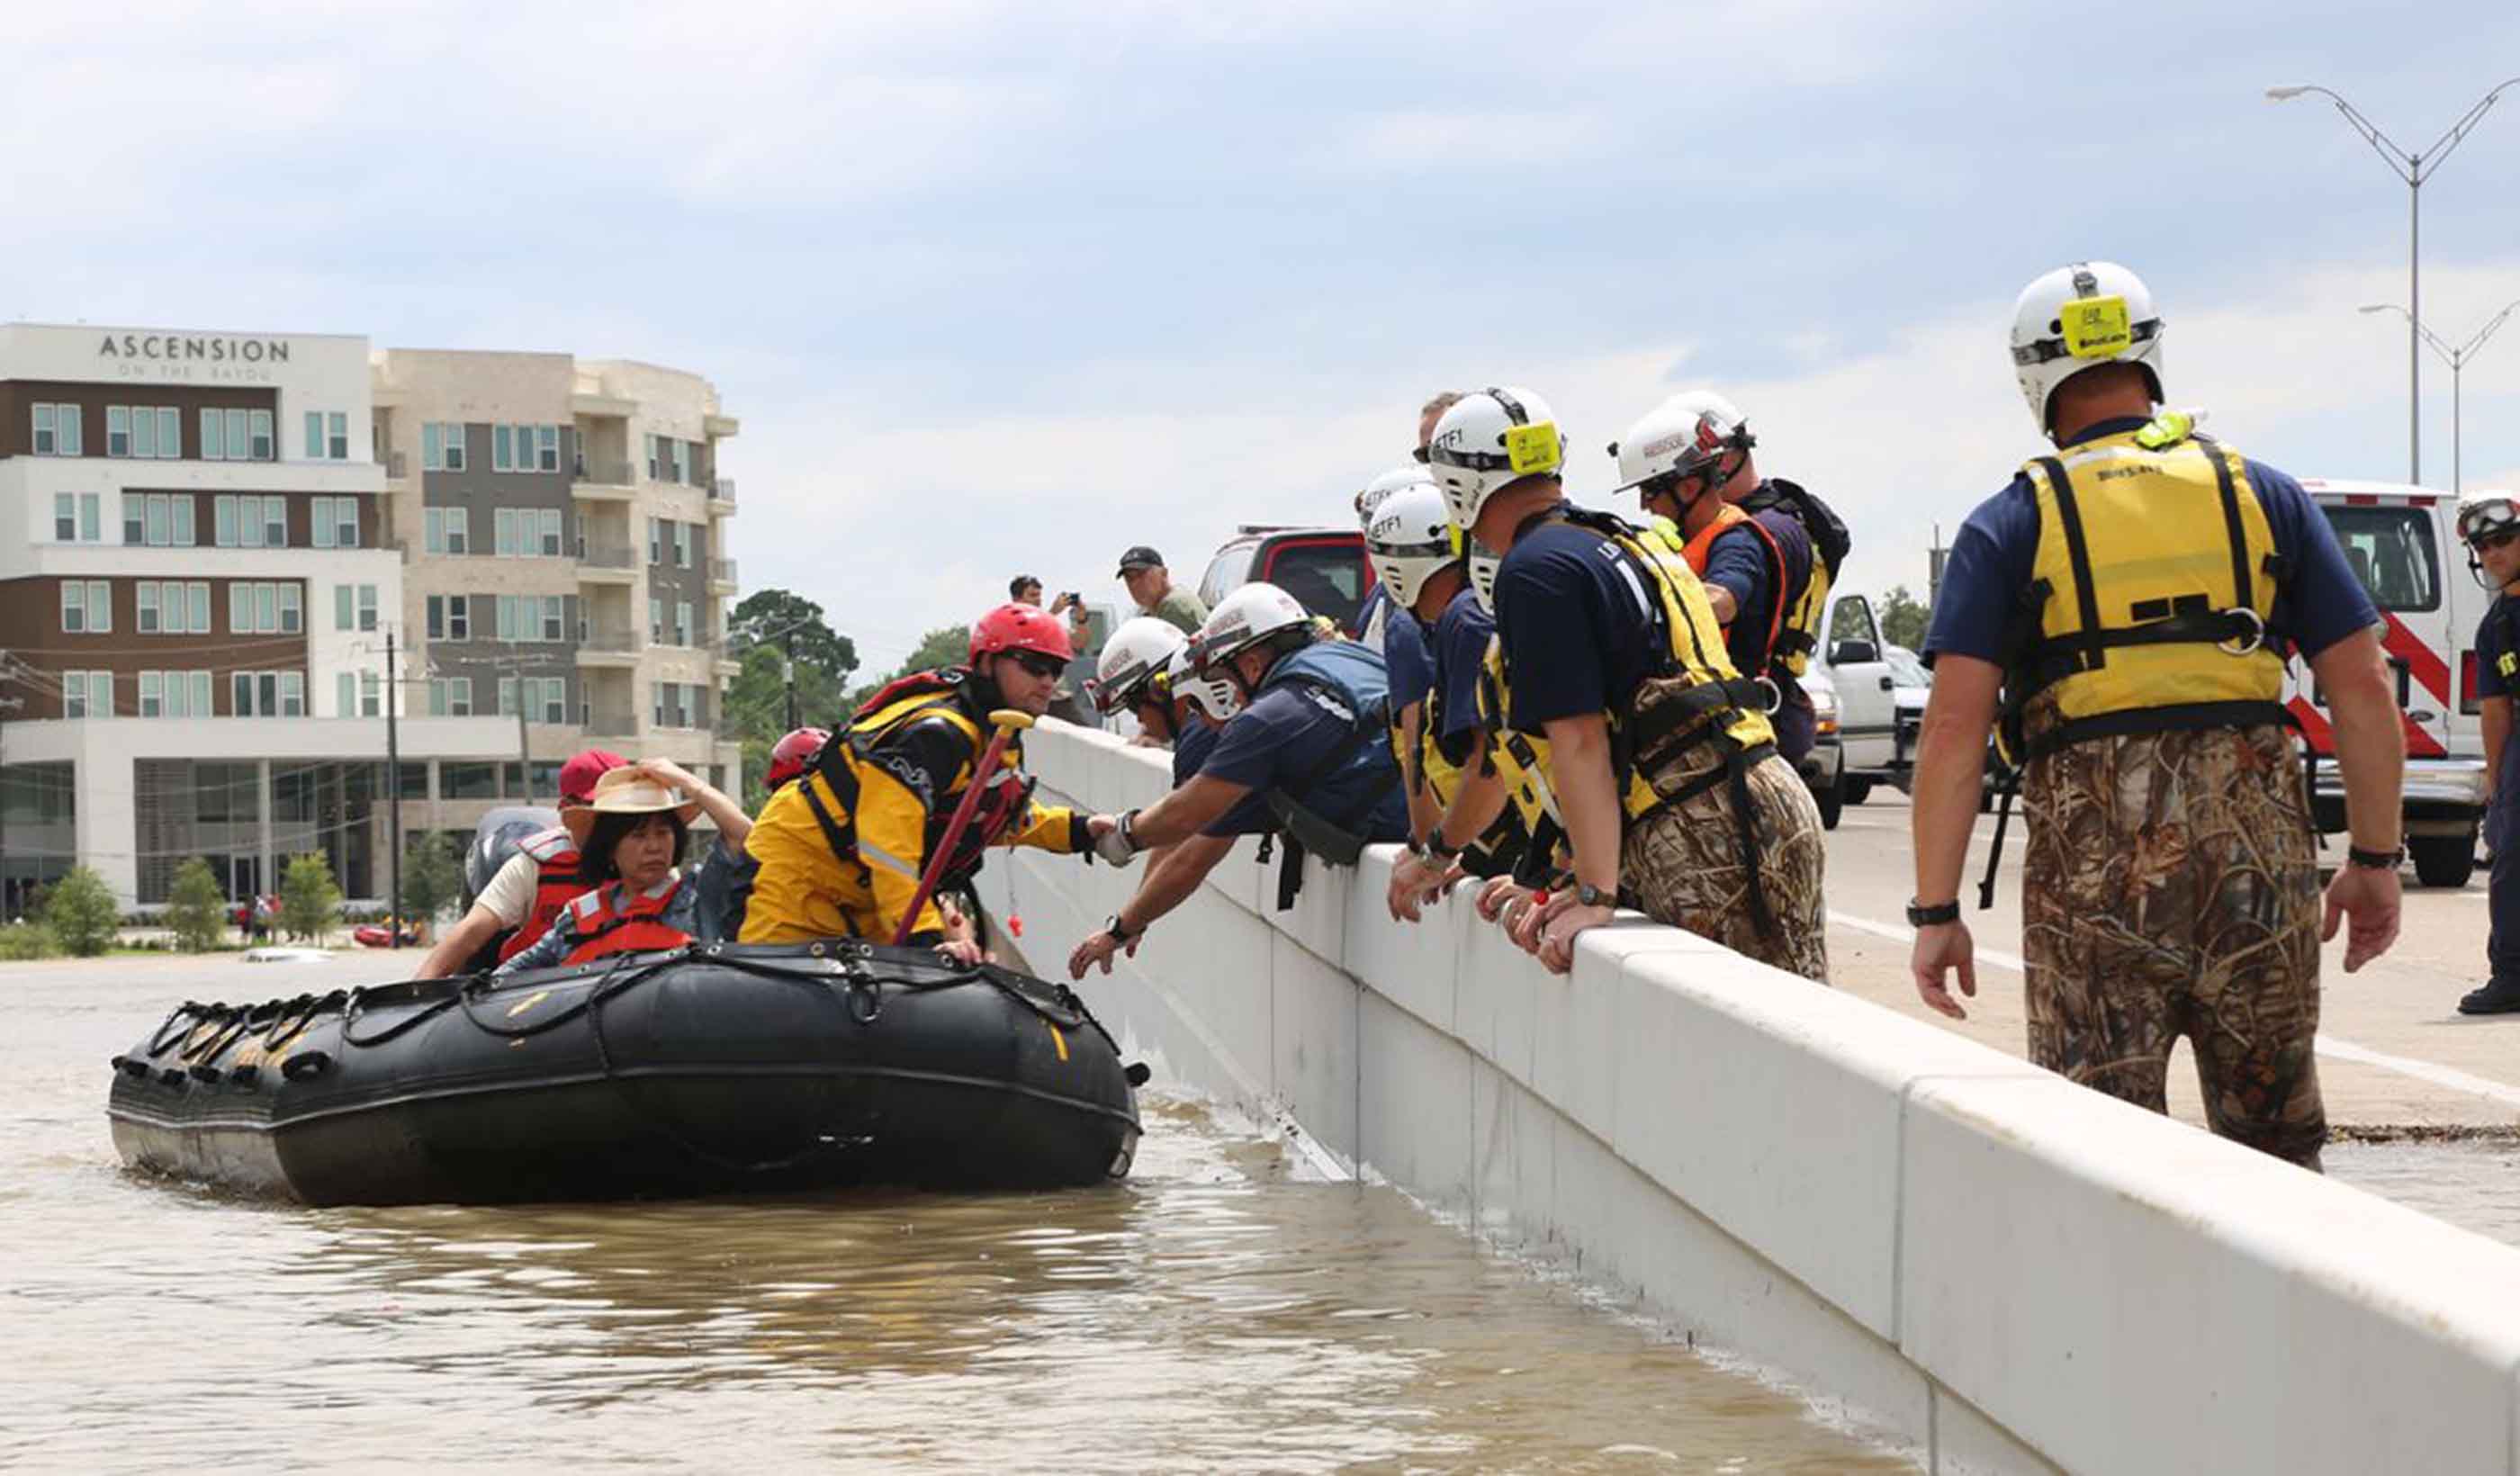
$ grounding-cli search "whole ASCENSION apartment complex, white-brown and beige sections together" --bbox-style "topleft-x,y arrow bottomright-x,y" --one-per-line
0,325 -> 738,909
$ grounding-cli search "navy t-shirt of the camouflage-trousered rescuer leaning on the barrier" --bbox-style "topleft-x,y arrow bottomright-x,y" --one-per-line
1497,508 -> 1656,733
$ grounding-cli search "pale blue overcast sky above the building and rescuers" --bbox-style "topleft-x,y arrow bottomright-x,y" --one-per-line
0,0 -> 2520,665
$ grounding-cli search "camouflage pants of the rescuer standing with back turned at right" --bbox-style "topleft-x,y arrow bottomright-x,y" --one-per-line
2021,725 -> 2328,1169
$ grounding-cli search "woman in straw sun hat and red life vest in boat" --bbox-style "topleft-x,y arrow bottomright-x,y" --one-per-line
494,758 -> 753,977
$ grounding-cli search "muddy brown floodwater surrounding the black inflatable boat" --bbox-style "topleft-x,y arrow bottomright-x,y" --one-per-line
0,957 -> 1912,1471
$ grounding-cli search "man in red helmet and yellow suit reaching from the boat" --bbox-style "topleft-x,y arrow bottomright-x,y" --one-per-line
741,602 -> 1114,965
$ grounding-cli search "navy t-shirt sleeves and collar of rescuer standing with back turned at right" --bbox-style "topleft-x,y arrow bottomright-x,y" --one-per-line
1925,418 -> 2379,662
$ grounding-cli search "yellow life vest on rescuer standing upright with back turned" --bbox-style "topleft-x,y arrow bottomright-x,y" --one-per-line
2006,418 -> 2286,756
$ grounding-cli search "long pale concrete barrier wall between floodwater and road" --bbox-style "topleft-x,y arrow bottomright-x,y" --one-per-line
980,723 -> 2520,1476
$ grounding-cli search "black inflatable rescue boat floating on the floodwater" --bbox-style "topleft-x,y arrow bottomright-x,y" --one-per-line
108,942 -> 1144,1204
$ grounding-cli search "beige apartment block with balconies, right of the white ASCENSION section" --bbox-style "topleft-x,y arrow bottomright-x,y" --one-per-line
371,347 -> 741,832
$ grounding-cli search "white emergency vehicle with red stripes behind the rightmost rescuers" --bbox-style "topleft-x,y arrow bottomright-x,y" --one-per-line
2286,479 -> 2492,886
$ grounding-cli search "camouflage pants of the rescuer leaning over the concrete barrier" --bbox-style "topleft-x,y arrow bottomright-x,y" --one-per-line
1620,745 -> 1830,985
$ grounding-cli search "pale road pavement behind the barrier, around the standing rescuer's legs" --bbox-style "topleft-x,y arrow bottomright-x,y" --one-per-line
1827,788 -> 2520,1136
